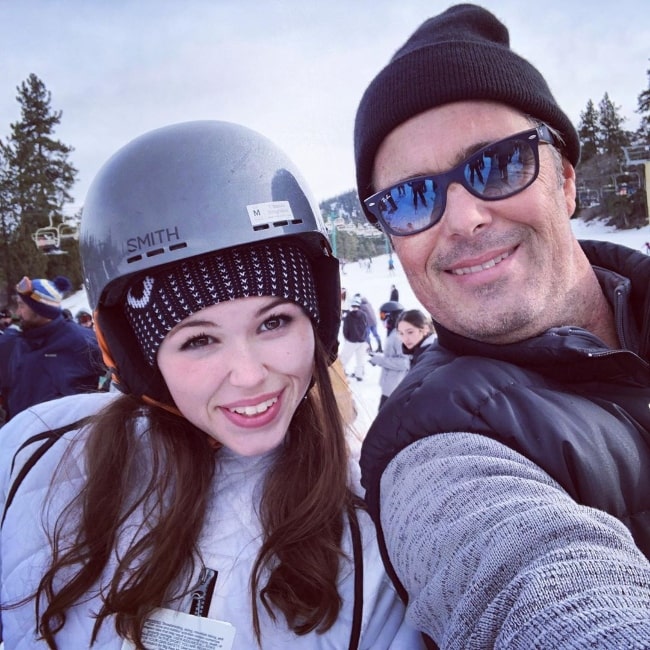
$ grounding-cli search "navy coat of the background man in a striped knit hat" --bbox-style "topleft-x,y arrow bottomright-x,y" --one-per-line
0,316 -> 105,418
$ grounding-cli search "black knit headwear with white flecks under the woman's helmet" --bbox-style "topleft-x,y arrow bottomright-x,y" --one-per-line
124,242 -> 319,366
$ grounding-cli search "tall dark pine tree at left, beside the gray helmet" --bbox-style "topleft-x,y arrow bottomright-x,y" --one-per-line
0,73 -> 81,298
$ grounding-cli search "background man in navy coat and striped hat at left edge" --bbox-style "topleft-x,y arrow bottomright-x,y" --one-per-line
0,276 -> 105,420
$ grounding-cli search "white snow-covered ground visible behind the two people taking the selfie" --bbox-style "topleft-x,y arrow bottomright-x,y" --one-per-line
64,219 -> 650,435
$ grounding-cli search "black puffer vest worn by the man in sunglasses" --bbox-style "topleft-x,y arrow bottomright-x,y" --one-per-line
361,242 -> 650,557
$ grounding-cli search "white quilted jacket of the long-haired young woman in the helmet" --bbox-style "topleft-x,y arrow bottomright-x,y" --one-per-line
0,393 -> 421,650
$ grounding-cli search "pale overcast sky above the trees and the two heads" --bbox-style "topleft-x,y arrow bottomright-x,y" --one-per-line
0,0 -> 650,213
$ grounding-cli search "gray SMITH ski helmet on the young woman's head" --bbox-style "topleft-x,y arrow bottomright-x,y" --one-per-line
80,121 -> 340,403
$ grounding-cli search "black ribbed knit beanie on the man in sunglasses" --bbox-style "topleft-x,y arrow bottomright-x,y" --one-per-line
354,4 -> 580,206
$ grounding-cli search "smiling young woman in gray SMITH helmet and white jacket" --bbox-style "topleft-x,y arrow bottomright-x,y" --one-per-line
0,122 -> 421,650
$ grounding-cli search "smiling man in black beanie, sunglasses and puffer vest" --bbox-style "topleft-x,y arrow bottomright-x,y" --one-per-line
355,5 -> 650,649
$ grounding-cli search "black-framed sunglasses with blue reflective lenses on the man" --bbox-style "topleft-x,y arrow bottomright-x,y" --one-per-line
363,124 -> 554,237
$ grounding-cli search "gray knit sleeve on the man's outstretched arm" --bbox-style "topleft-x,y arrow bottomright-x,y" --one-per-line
381,433 -> 650,650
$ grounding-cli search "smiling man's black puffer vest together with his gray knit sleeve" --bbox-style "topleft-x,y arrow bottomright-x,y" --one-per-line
361,242 -> 650,649
